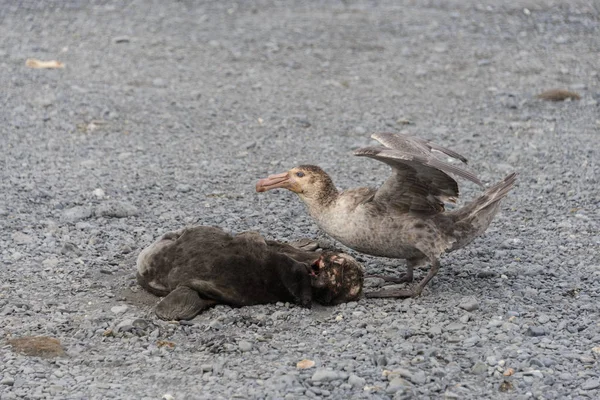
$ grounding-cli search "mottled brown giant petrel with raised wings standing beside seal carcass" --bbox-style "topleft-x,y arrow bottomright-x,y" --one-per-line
257,134 -> 516,297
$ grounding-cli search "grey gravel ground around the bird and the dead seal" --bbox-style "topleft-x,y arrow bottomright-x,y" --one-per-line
0,0 -> 600,400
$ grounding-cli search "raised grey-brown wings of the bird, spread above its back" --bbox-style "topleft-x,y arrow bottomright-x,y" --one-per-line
354,133 -> 483,214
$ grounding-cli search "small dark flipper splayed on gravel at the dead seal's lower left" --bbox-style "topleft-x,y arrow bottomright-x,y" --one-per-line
154,286 -> 217,321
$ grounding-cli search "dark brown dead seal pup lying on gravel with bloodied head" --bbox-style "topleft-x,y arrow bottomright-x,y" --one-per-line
137,226 -> 364,320
